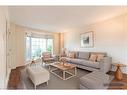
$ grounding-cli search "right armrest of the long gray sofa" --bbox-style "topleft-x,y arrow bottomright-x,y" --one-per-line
99,57 -> 112,73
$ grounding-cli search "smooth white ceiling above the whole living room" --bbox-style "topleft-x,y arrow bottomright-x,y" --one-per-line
9,6 -> 127,32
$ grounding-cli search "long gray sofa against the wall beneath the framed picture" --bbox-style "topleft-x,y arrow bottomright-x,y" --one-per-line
66,52 -> 112,73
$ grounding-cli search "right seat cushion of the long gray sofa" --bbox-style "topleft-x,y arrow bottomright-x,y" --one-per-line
78,60 -> 100,68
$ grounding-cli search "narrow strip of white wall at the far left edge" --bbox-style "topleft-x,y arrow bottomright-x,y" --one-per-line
0,7 -> 8,89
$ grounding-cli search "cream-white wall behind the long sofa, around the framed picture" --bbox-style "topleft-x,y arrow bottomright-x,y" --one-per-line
64,14 -> 127,73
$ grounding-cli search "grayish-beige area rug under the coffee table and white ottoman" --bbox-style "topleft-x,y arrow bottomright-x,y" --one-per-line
18,64 -> 114,90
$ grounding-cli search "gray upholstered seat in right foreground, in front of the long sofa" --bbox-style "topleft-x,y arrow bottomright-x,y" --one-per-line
80,71 -> 110,89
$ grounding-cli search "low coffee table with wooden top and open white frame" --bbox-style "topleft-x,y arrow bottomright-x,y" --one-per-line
49,62 -> 77,80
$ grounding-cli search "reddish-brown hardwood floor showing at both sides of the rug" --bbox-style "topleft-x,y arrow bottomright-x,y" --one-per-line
8,67 -> 127,90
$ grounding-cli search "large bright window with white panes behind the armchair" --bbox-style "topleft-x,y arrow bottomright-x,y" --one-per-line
26,37 -> 53,61
